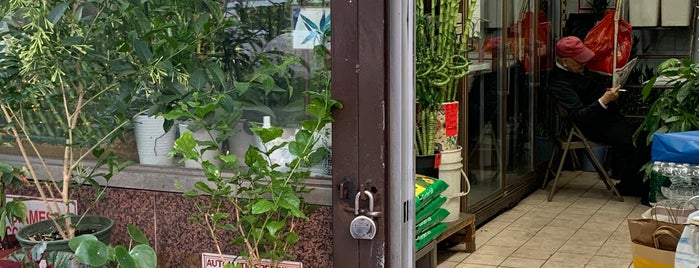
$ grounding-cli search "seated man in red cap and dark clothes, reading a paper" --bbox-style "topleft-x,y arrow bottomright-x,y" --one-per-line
548,36 -> 650,204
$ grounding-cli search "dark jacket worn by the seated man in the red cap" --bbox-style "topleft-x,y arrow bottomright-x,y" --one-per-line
548,66 -> 625,136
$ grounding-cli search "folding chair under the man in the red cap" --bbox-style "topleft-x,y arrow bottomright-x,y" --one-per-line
541,103 -> 624,202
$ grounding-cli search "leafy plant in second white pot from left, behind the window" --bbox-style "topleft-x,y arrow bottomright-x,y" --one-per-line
123,0 -> 240,168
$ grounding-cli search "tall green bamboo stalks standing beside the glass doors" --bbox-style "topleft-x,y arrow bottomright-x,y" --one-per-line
415,0 -> 477,155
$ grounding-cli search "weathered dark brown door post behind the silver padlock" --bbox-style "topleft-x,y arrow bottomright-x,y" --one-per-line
331,0 -> 389,267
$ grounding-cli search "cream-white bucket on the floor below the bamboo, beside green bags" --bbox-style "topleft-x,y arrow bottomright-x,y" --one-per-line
439,146 -> 470,222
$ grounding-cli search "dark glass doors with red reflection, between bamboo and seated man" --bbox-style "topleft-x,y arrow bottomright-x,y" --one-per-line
468,0 -> 552,205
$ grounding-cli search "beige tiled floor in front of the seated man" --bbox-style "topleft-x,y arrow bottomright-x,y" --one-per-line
438,171 -> 648,268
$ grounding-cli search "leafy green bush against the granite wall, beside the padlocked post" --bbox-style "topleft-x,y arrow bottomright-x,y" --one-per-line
173,63 -> 341,262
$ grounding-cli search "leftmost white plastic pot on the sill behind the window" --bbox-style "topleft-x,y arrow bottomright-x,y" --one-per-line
134,115 -> 176,166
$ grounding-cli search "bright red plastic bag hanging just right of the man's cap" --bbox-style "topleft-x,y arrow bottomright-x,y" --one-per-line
583,10 -> 631,75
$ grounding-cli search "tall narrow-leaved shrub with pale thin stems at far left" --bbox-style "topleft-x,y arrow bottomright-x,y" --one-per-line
0,0 -> 154,253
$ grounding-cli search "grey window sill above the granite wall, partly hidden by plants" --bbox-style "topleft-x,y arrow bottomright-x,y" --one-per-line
0,154 -> 332,206
